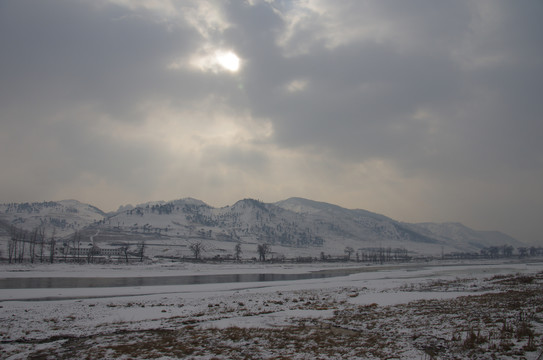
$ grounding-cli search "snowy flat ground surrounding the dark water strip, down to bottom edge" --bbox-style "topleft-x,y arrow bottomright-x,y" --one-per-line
0,262 -> 543,359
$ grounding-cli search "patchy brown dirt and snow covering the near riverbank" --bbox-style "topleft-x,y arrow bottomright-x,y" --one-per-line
4,273 -> 543,359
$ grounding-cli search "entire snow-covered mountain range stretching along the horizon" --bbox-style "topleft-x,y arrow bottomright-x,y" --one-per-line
0,198 -> 522,256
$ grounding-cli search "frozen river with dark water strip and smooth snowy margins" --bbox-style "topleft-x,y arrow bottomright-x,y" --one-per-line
0,263 -> 543,302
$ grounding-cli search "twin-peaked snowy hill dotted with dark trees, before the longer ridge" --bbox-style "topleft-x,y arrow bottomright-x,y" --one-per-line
98,198 -> 323,247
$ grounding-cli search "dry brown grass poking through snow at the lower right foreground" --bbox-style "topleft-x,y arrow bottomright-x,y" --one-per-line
17,274 -> 543,360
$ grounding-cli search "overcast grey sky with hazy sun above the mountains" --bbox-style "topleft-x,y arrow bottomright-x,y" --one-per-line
0,0 -> 543,244
